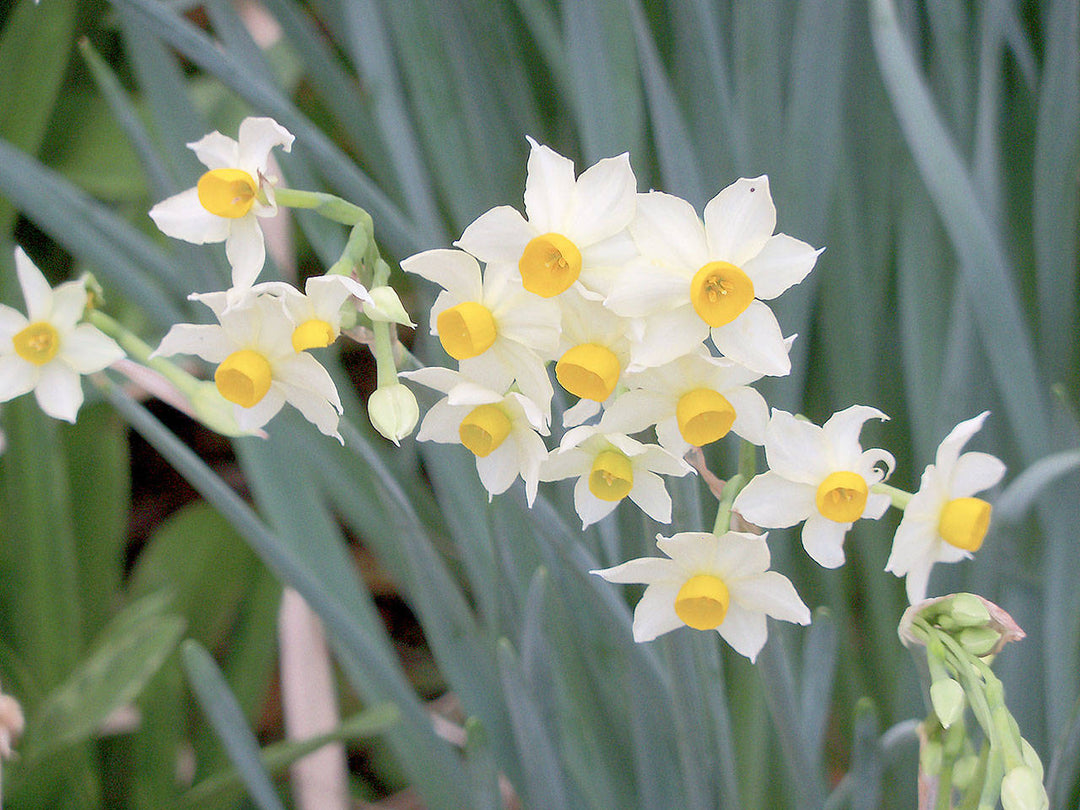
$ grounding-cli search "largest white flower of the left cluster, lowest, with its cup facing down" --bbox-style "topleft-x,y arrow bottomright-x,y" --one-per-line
151,293 -> 343,443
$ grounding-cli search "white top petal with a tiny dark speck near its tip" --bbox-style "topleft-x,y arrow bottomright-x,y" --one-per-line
704,175 -> 777,267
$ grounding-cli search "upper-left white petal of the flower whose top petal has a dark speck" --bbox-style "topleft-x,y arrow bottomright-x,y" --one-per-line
630,191 -> 710,273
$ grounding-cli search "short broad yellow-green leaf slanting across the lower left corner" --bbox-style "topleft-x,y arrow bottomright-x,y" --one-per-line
23,595 -> 184,759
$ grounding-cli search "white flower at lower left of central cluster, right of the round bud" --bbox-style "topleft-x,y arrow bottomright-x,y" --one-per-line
401,367 -> 548,507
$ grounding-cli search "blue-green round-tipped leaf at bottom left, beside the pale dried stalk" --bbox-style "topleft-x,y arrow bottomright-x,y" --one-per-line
180,639 -> 284,810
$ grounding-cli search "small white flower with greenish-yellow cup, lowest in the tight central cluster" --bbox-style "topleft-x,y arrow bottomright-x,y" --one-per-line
540,424 -> 693,528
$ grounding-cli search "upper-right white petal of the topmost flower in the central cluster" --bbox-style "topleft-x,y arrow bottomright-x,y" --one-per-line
565,153 -> 637,247
